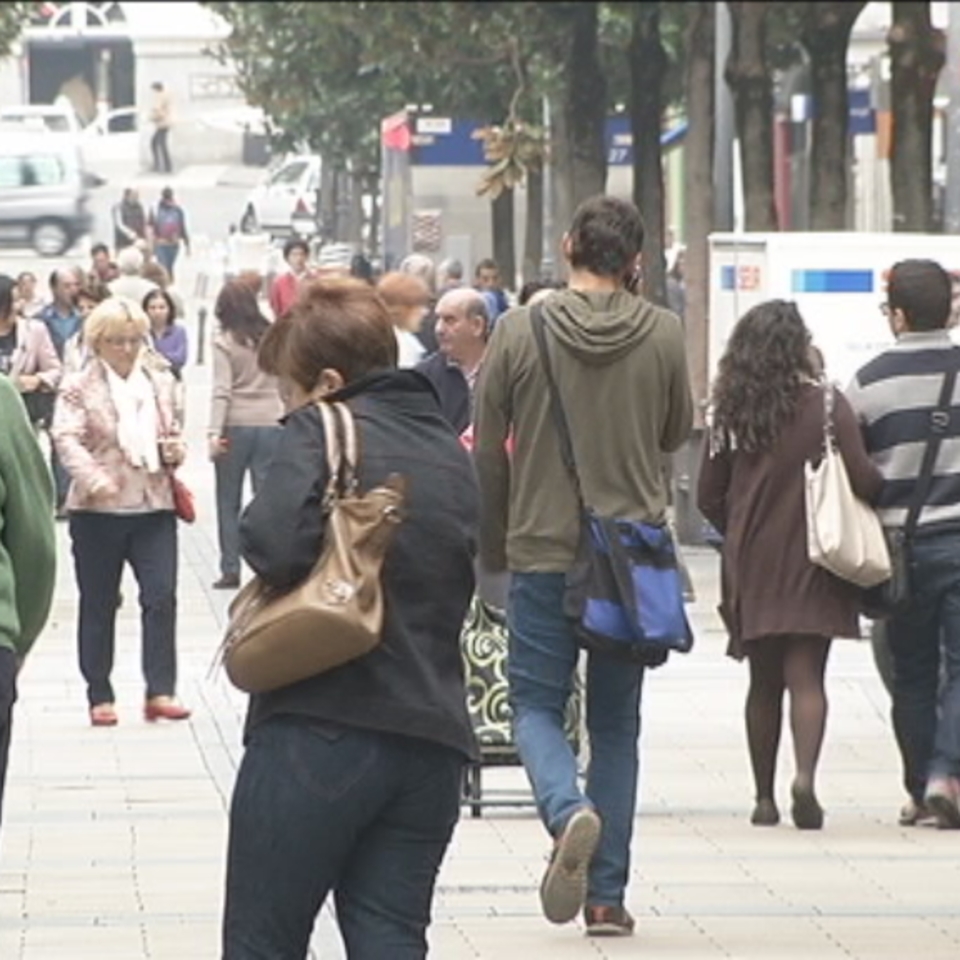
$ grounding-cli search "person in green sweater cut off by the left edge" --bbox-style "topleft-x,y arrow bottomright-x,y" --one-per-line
0,377 -> 57,817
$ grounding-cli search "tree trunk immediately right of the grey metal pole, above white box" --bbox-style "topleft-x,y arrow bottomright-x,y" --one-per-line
725,2 -> 777,231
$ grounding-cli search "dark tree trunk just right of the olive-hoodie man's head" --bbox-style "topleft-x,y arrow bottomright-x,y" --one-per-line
630,2 -> 667,305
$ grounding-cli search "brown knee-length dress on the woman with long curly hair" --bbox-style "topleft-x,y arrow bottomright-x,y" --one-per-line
698,384 -> 883,660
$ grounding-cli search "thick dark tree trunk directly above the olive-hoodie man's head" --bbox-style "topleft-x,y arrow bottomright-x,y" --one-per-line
552,3 -> 607,248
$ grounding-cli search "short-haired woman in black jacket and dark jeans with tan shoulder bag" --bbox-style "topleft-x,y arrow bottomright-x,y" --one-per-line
223,280 -> 479,960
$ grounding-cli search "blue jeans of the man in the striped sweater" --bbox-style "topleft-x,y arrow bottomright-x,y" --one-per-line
888,531 -> 960,802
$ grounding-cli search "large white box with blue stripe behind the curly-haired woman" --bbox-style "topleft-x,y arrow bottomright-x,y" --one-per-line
708,233 -> 960,386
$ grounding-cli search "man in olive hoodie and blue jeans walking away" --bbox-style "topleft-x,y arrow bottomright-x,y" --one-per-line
475,197 -> 693,935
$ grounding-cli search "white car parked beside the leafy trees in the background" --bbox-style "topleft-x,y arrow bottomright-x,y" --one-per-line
240,154 -> 320,237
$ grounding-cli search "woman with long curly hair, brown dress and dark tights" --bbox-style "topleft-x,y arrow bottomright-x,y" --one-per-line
698,300 -> 882,830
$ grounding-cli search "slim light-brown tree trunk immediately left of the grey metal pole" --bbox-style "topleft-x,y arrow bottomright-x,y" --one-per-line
683,2 -> 716,428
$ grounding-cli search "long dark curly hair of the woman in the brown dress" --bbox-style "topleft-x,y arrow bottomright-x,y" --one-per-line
712,300 -> 817,453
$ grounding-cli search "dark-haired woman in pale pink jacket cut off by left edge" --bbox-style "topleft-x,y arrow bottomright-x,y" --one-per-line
0,274 -> 62,424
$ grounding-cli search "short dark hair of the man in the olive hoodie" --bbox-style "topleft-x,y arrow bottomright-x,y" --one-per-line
569,196 -> 644,279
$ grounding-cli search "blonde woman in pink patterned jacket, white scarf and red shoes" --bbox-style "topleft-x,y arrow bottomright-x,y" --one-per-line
52,298 -> 190,727
